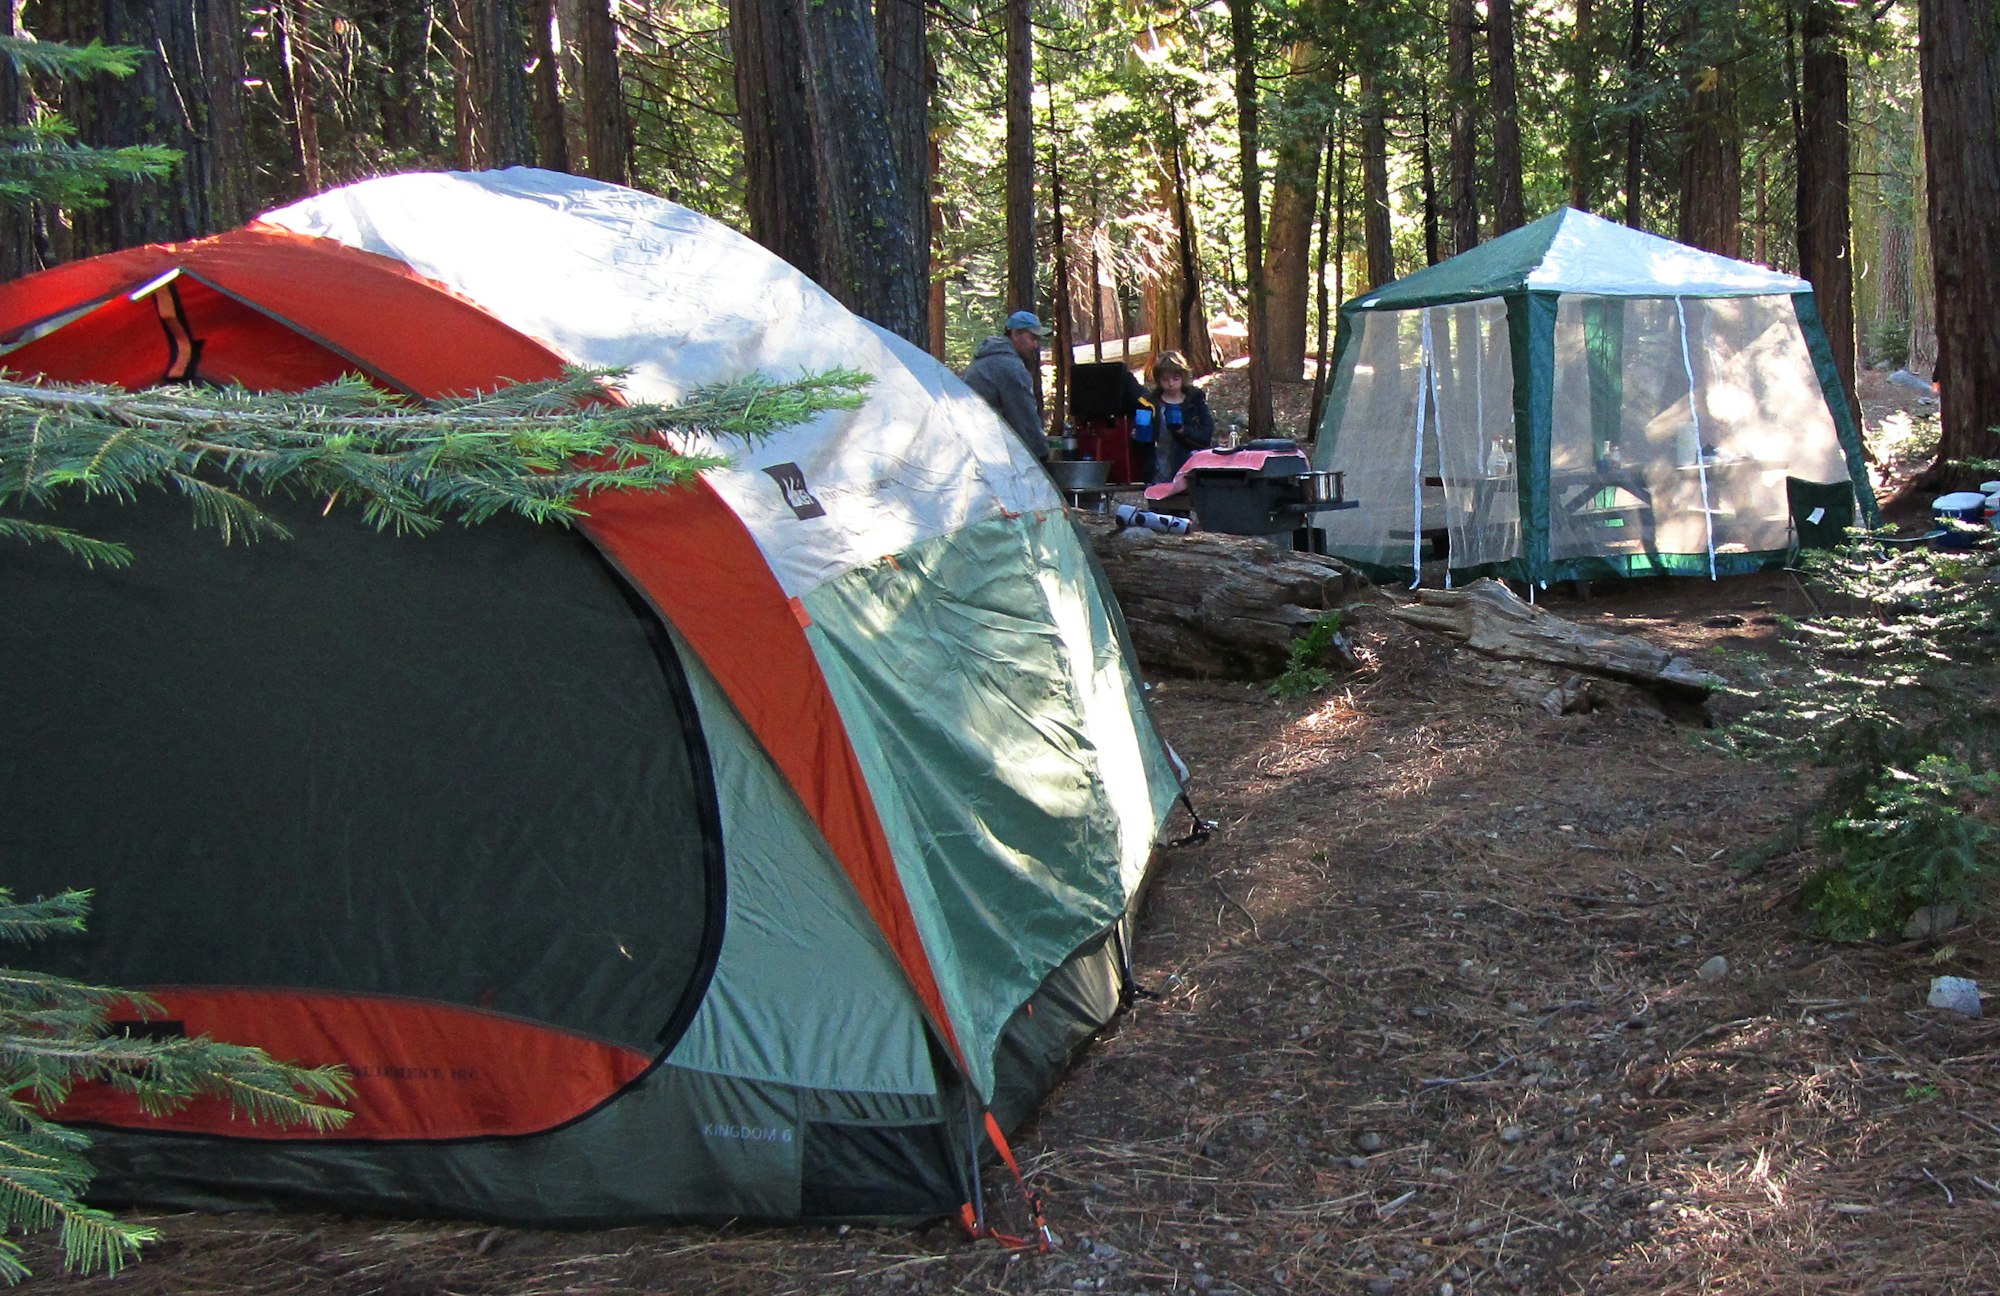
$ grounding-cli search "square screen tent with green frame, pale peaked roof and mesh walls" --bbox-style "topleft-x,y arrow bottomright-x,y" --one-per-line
1314,208 -> 1876,584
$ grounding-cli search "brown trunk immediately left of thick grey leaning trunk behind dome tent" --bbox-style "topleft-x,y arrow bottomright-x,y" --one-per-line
732,0 -> 824,280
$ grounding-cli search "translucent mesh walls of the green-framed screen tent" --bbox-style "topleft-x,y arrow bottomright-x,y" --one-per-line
1316,294 -> 1848,574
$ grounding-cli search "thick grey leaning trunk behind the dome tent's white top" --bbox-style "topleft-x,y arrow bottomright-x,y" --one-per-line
794,0 -> 926,346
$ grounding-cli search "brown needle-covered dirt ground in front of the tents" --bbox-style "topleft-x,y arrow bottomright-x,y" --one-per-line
30,370 -> 2000,1296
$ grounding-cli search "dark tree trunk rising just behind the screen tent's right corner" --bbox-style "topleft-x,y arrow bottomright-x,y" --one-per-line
1798,0 -> 1860,422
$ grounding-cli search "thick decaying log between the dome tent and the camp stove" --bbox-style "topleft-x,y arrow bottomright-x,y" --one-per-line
1076,514 -> 1362,680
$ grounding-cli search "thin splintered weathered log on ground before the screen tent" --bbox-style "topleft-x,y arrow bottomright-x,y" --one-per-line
1390,580 -> 1722,700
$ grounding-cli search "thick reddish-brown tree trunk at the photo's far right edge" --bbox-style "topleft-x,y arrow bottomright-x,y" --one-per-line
1918,0 -> 2000,488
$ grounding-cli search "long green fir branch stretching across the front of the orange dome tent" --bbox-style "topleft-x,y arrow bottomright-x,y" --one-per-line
0,370 -> 870,566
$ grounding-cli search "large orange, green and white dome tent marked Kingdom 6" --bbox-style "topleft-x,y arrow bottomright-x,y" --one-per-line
0,170 -> 1178,1222
